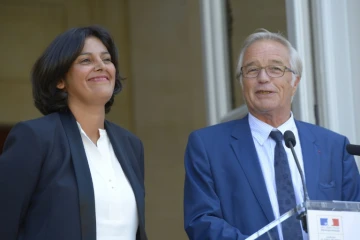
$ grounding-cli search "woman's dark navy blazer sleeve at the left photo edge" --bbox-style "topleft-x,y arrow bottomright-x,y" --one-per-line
0,123 -> 43,240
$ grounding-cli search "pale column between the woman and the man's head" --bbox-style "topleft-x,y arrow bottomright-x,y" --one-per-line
200,0 -> 231,125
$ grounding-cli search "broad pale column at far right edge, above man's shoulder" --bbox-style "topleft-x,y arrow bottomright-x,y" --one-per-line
312,0 -> 360,142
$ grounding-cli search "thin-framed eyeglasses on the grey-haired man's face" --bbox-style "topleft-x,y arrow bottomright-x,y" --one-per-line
240,65 -> 295,78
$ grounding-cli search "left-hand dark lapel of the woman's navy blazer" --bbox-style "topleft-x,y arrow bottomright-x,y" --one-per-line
59,112 -> 96,240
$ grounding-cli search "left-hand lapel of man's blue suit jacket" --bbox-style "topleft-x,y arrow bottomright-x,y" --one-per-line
231,117 -> 275,222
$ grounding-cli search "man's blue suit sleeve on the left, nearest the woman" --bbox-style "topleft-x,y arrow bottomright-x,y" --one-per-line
184,132 -> 247,240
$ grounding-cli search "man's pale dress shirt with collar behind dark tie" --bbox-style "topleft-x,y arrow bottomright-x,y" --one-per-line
249,113 -> 308,240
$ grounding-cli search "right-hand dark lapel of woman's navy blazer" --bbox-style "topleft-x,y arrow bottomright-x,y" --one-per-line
105,121 -> 145,233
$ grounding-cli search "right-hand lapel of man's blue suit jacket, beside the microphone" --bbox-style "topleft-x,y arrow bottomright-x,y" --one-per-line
295,121 -> 320,199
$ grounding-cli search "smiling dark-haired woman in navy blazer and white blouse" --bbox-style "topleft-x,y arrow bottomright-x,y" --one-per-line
0,26 -> 147,240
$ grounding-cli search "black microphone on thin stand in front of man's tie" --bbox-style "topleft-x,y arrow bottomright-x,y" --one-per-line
284,130 -> 310,232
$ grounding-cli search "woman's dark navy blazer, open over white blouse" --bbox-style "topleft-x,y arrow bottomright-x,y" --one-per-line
0,112 -> 147,240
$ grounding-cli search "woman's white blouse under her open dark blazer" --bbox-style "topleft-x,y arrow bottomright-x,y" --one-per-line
78,123 -> 138,240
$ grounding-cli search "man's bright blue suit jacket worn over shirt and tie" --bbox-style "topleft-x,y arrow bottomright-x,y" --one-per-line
184,117 -> 360,240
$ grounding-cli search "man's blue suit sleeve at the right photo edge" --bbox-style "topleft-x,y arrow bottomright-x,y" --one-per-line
342,138 -> 360,202
